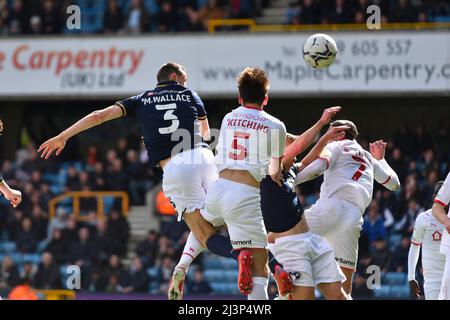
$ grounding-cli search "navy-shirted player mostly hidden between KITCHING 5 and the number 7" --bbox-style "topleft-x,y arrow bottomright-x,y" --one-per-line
261,107 -> 347,300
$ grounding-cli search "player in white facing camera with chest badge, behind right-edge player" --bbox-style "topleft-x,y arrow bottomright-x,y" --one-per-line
408,181 -> 445,300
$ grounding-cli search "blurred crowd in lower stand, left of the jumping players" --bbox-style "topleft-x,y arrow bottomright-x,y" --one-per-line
0,139 -> 165,296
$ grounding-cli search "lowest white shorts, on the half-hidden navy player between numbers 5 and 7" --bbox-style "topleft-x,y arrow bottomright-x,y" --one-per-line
269,232 -> 346,287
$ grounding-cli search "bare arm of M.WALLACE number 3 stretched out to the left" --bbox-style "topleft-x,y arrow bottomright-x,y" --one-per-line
38,105 -> 123,159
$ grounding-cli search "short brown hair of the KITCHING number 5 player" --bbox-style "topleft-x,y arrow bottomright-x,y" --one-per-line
237,68 -> 269,105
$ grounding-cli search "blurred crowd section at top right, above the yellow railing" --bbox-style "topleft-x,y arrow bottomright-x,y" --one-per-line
286,0 -> 450,24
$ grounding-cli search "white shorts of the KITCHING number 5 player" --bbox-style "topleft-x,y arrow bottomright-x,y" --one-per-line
201,178 -> 267,249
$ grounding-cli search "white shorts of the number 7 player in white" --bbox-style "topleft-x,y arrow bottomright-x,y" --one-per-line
305,198 -> 363,271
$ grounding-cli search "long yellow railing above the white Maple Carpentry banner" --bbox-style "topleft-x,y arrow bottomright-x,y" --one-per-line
208,19 -> 450,33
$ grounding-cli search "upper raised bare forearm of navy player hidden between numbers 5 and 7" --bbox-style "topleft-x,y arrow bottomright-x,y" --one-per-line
284,106 -> 342,162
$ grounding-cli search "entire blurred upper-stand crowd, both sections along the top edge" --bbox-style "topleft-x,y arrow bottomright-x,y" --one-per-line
0,0 -> 450,35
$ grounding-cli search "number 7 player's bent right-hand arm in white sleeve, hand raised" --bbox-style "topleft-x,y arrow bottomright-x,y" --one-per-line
370,140 -> 400,191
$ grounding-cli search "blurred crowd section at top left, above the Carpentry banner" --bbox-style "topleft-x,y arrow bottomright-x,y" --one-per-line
0,0 -> 269,35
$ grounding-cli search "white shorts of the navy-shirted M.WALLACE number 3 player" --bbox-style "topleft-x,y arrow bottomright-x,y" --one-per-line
162,148 -> 218,221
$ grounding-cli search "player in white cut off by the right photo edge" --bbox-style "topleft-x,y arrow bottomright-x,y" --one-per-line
431,173 -> 450,300
